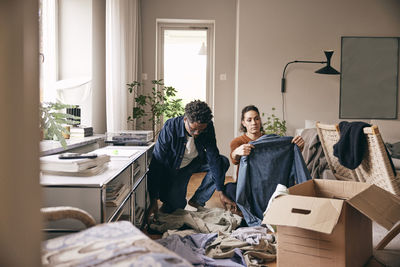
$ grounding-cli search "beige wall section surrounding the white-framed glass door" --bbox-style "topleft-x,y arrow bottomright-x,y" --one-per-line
141,0 -> 236,176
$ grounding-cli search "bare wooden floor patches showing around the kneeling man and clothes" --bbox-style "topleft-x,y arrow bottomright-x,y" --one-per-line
147,173 -> 276,267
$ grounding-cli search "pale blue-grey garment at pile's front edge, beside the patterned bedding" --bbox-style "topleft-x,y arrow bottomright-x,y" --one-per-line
156,233 -> 245,267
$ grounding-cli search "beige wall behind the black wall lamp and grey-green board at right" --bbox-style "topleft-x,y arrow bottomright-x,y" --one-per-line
237,0 -> 400,139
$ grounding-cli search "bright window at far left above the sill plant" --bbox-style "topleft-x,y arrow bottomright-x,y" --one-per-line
39,0 -> 92,125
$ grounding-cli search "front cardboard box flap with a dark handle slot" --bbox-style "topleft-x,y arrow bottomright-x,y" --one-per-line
263,195 -> 344,234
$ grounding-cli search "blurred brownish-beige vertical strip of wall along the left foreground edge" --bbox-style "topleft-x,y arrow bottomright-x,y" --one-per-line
0,0 -> 41,266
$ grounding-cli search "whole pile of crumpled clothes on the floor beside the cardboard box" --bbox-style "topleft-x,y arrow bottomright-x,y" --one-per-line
149,208 -> 276,267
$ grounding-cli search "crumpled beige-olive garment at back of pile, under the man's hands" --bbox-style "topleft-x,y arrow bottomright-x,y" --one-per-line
150,208 -> 242,234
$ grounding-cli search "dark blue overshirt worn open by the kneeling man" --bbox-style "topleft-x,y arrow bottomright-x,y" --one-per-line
148,116 -> 225,198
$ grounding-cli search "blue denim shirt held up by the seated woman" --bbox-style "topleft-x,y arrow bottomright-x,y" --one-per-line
236,135 -> 311,226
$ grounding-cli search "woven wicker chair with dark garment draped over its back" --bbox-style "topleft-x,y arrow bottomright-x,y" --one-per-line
316,122 -> 400,250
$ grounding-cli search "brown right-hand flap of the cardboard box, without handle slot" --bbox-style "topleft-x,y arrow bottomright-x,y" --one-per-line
347,185 -> 400,230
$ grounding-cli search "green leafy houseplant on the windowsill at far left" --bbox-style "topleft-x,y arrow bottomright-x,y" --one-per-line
39,102 -> 79,148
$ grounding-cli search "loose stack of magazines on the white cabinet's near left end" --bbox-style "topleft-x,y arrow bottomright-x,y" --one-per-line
40,155 -> 110,176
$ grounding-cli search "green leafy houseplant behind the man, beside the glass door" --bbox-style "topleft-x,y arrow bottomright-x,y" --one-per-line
127,79 -> 185,137
